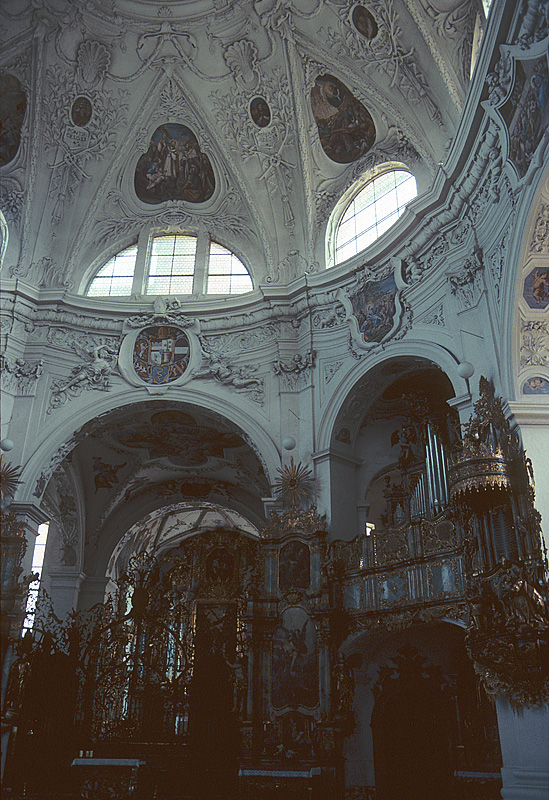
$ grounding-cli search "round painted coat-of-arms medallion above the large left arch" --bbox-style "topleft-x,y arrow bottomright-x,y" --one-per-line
133,325 -> 190,385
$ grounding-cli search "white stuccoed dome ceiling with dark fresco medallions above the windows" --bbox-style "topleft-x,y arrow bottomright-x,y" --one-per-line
0,0 -> 483,291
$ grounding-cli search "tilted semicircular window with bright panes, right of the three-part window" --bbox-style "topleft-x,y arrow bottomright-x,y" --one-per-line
335,169 -> 417,264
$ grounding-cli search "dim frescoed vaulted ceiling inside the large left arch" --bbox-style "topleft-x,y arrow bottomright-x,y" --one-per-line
44,400 -> 270,566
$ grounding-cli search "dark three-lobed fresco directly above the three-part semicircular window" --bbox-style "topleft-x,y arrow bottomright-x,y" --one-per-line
134,122 -> 215,204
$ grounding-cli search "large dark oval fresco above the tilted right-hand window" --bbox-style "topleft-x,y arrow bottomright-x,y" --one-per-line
311,75 -> 376,164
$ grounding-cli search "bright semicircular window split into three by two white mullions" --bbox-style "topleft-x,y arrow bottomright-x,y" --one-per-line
86,234 -> 253,297
